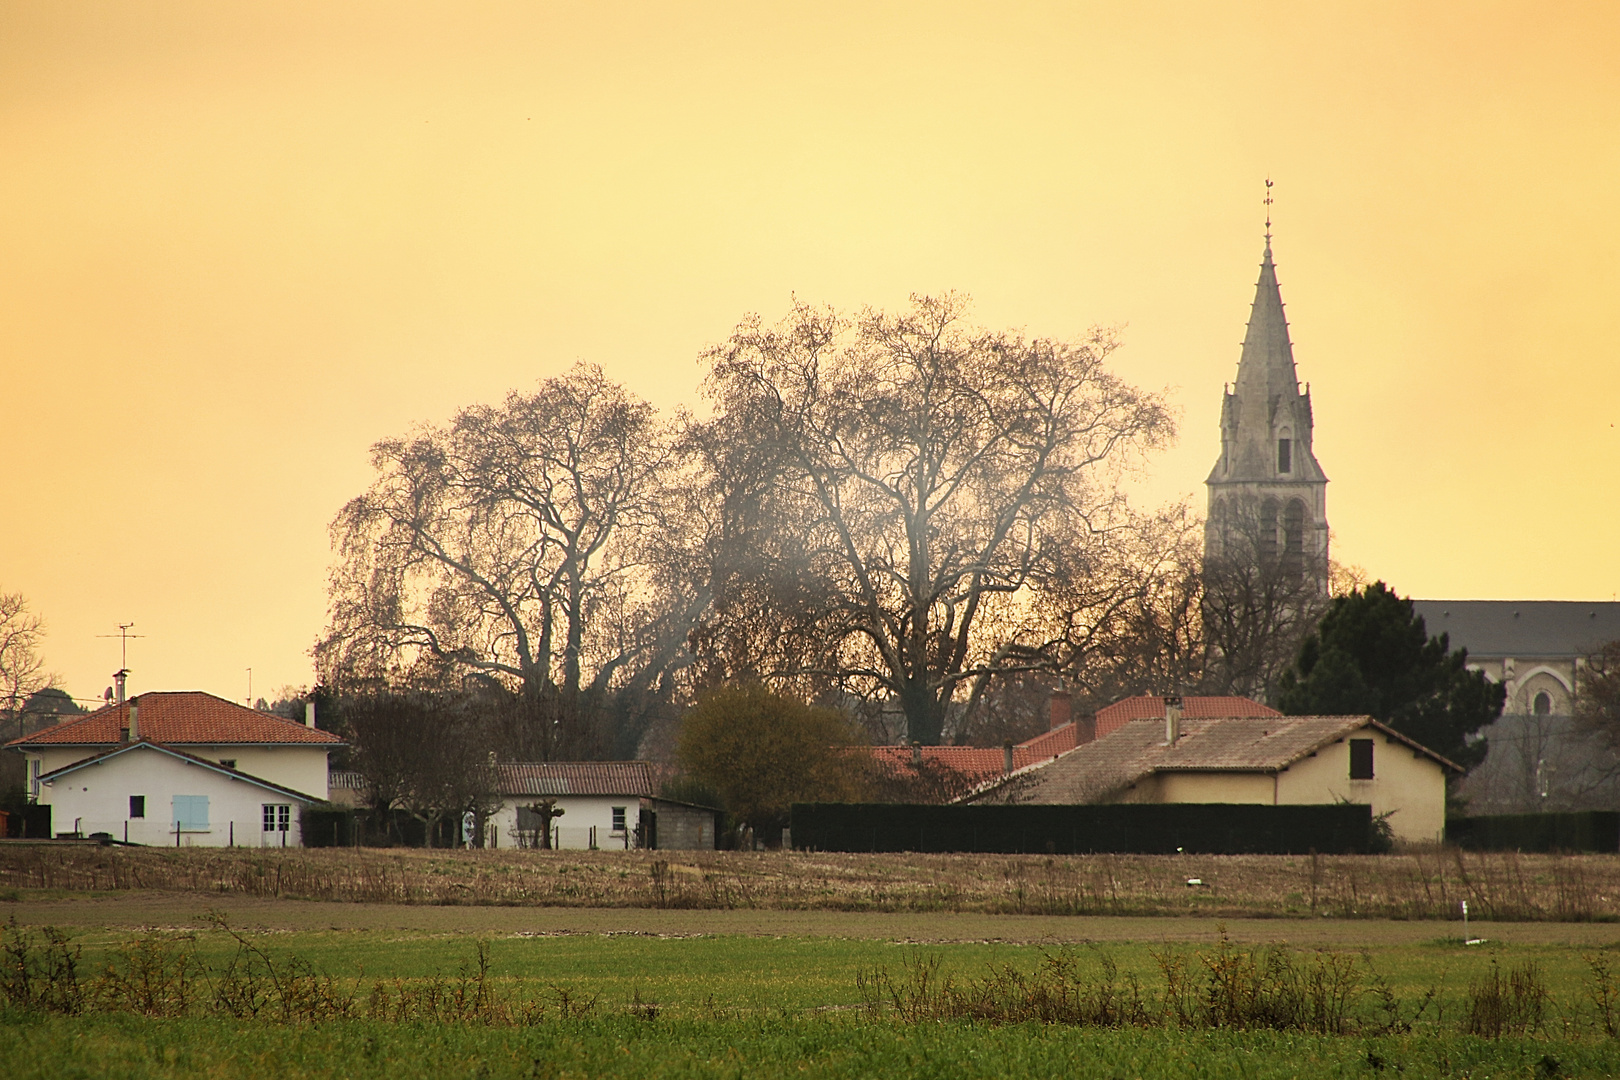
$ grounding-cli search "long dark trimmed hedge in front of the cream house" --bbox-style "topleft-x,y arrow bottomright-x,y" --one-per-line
792,803 -> 1374,855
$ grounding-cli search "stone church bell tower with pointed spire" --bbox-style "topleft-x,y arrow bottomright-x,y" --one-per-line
1204,233 -> 1327,593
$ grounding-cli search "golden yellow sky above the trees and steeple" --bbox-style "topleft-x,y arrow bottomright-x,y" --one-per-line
0,0 -> 1620,698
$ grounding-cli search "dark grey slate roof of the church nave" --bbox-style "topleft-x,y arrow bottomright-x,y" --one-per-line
1413,601 -> 1620,659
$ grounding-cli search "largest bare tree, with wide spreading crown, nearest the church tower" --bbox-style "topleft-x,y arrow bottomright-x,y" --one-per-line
703,295 -> 1173,743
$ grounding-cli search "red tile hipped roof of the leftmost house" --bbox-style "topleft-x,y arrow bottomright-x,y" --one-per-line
6,690 -> 343,746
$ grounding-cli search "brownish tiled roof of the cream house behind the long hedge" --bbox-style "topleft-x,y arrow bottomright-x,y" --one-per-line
969,716 -> 1461,803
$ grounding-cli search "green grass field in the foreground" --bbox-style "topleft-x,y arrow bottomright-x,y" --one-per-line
0,894 -> 1620,1080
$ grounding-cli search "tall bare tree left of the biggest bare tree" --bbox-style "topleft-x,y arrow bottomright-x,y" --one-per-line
316,364 -> 703,759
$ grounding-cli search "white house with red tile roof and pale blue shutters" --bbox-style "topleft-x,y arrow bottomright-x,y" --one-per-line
6,691 -> 343,847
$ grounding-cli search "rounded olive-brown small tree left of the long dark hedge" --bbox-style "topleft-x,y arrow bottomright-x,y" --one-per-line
677,683 -> 867,844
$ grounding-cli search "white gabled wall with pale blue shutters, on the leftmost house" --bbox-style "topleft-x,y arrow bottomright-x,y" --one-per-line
39,748 -> 312,847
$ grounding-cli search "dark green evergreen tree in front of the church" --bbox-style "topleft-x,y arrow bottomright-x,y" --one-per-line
1278,581 -> 1507,767
